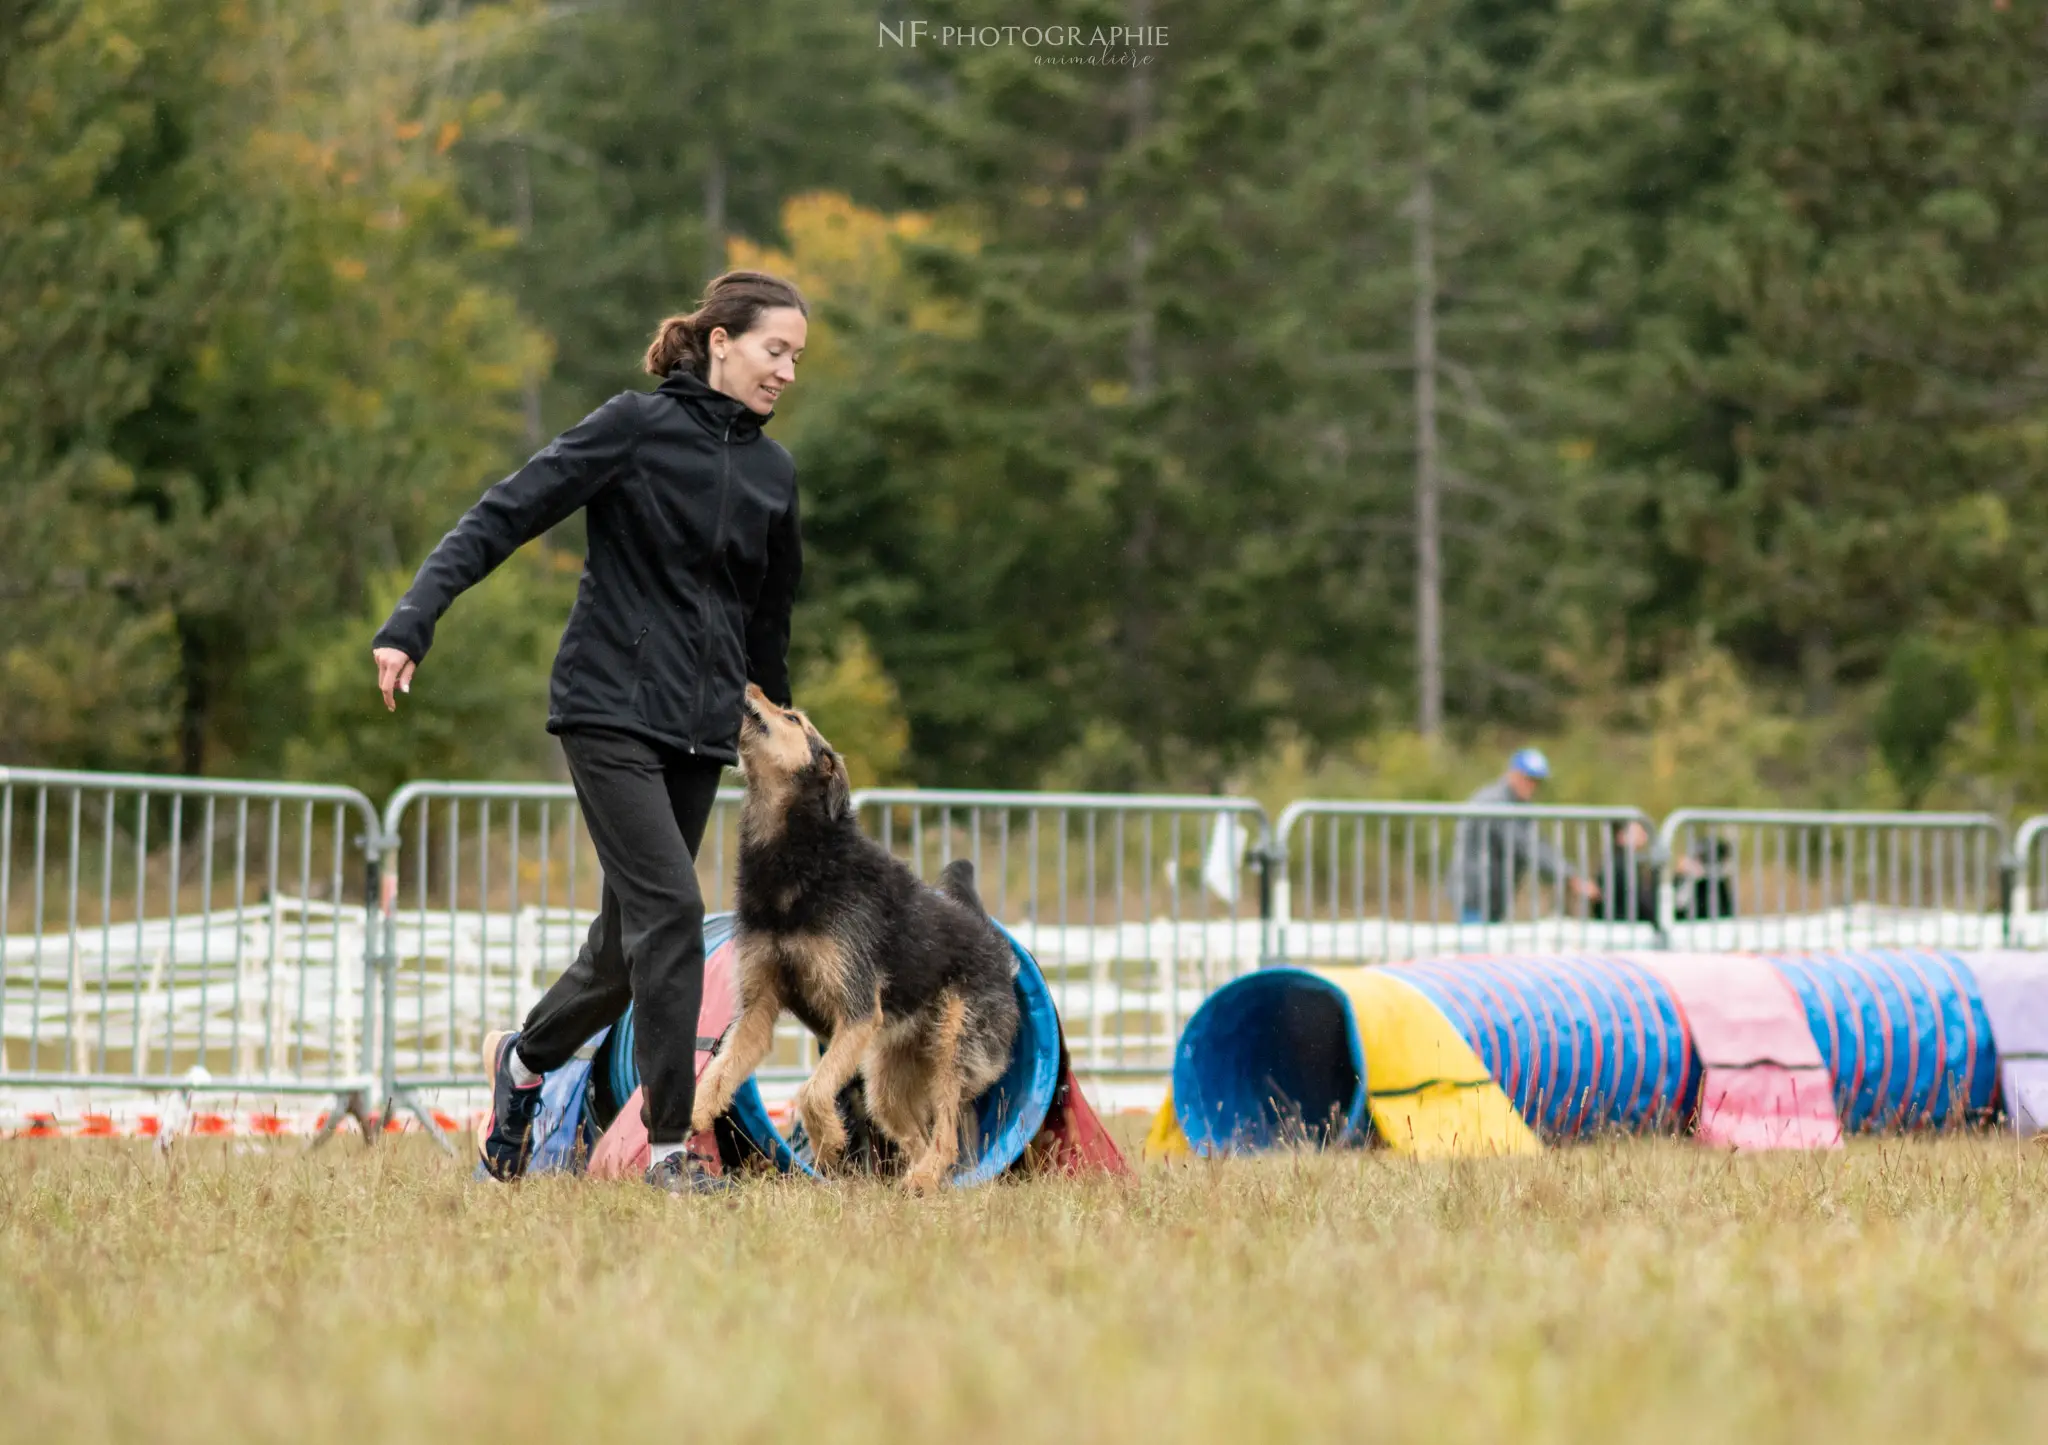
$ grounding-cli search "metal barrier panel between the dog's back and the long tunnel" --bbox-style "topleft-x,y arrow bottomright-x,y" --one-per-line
854,788 -> 1272,1075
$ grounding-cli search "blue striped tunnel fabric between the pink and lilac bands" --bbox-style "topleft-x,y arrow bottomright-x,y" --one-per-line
1772,950 -> 1997,1132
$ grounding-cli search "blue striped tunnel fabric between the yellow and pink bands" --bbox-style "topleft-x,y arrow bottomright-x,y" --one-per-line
1395,956 -> 1700,1138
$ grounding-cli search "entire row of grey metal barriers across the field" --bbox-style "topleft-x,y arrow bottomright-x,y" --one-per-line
0,753 -> 2048,1126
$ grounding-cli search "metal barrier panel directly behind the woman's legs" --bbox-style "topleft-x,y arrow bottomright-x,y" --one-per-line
383,782 -> 743,1113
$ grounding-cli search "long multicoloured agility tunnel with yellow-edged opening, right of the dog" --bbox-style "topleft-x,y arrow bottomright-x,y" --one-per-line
1147,950 -> 2048,1154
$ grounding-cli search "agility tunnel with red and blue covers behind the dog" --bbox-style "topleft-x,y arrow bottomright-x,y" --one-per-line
530,913 -> 1124,1187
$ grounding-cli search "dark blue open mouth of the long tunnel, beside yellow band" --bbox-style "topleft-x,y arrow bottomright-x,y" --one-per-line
1174,968 -> 1366,1154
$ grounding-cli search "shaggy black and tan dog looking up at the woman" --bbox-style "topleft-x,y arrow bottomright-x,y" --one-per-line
692,686 -> 1018,1193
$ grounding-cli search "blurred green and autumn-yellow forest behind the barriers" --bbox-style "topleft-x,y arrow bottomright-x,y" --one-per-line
0,0 -> 2048,811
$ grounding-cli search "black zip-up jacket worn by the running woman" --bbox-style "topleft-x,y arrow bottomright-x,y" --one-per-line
375,370 -> 803,763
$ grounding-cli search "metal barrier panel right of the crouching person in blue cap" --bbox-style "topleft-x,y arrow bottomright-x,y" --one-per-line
1657,808 -> 2007,952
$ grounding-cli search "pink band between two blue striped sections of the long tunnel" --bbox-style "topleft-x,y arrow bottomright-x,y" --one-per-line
1630,954 -> 1841,1148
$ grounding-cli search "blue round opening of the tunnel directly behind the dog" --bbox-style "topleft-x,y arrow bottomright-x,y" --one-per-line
600,913 -> 1061,1187
